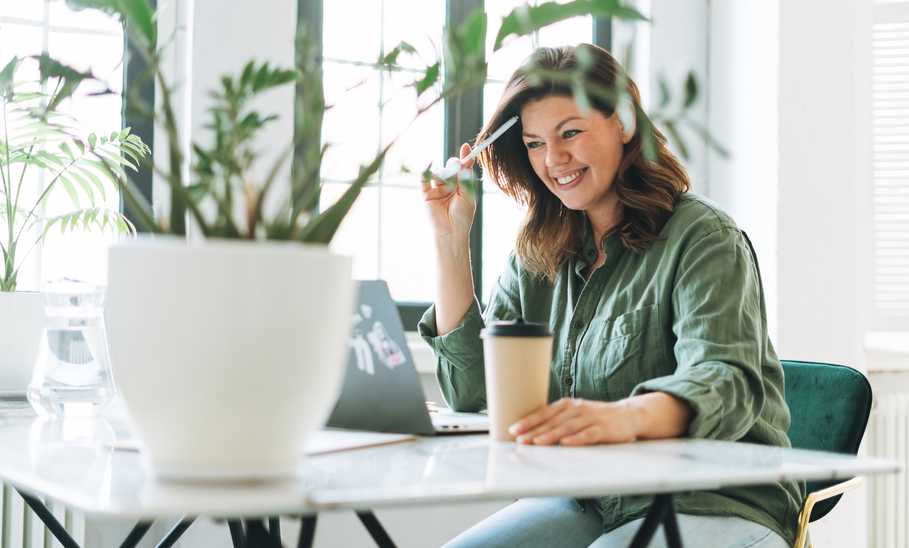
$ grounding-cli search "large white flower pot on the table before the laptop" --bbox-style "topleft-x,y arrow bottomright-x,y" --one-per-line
107,239 -> 354,479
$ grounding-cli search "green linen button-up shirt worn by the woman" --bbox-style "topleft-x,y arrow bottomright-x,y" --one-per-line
418,193 -> 804,544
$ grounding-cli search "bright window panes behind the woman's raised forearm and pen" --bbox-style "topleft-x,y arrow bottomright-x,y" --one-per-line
321,0 -> 609,329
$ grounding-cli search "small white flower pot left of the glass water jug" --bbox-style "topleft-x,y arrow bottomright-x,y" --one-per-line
0,292 -> 44,394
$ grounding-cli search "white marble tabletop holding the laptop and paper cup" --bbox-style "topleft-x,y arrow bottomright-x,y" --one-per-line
0,417 -> 899,548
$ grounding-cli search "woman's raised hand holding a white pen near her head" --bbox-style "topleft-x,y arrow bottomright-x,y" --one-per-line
423,143 -> 477,240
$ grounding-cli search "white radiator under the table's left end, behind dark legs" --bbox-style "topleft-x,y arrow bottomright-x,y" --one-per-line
0,484 -> 85,548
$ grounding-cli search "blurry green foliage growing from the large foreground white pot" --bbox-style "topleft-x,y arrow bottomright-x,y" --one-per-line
48,0 -> 715,243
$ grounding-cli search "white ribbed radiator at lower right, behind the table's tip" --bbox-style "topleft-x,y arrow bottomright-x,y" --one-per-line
865,393 -> 909,548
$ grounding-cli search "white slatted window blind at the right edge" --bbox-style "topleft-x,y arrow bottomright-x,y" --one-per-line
871,0 -> 909,331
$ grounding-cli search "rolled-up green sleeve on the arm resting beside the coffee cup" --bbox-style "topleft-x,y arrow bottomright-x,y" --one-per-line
633,227 -> 767,440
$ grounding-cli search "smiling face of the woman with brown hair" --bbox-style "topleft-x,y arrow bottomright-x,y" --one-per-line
521,95 -> 627,217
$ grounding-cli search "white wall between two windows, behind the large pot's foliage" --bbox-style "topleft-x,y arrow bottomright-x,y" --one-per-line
155,0 -> 297,233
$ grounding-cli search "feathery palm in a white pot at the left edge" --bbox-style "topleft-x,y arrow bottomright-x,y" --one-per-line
0,57 -> 148,394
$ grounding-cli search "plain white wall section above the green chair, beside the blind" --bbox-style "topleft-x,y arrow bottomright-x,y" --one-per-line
778,0 -> 870,548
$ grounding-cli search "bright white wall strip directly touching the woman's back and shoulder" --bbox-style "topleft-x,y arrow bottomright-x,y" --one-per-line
706,0 -> 779,342
